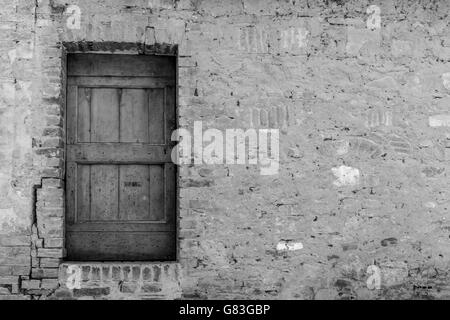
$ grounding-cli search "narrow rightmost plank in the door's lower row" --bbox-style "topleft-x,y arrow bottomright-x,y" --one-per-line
149,165 -> 165,221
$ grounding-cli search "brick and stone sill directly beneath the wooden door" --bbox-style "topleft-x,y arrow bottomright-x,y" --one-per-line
58,262 -> 181,299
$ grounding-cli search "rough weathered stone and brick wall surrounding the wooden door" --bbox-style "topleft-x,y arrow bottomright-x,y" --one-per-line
0,0 -> 450,299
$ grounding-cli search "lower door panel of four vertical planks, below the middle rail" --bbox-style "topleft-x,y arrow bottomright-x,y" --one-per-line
76,164 -> 166,222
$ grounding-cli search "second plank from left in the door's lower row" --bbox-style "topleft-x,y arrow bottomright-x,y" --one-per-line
91,164 -> 119,221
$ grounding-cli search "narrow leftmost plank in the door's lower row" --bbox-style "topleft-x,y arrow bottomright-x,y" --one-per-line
76,164 -> 91,222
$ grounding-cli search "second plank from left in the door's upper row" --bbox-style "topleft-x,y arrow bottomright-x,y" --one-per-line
91,88 -> 121,142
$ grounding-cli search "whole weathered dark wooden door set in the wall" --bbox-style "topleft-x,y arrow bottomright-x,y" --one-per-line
66,54 -> 176,261
